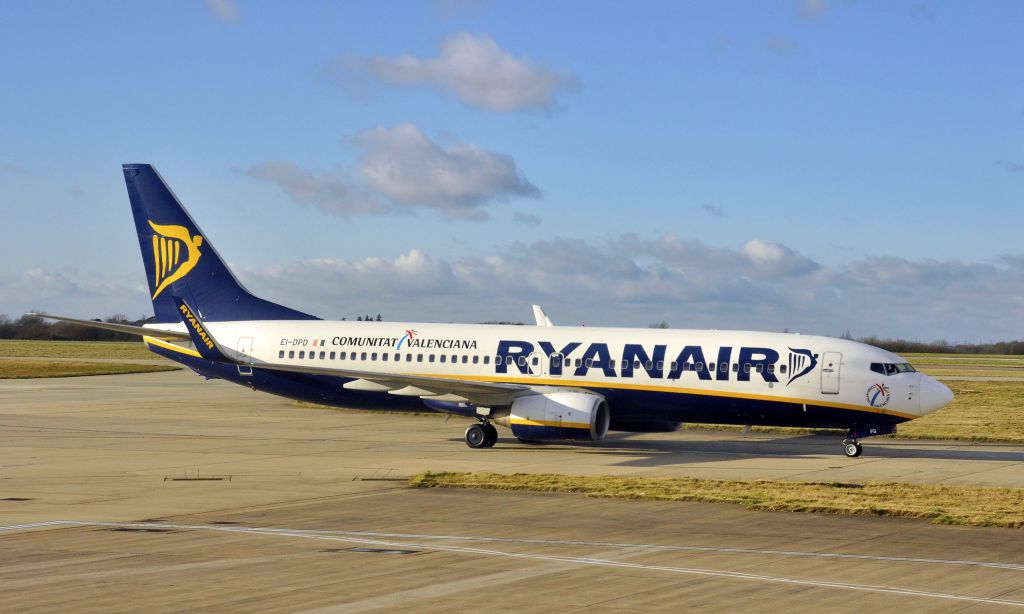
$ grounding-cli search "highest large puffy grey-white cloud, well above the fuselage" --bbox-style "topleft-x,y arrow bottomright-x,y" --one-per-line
326,33 -> 579,112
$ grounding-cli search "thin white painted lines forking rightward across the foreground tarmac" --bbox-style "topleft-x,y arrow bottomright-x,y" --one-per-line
0,520 -> 1024,607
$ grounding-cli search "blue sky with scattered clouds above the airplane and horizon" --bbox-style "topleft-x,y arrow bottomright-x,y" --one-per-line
0,0 -> 1024,342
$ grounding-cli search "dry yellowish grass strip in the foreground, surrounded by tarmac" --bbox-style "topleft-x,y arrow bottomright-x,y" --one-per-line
410,472 -> 1024,529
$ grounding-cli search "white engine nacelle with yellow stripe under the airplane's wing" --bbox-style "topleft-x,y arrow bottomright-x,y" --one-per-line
495,392 -> 611,441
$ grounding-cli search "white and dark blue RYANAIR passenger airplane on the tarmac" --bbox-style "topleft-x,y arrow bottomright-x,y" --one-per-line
35,164 -> 953,457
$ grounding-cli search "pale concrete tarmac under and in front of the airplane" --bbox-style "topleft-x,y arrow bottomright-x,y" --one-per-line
0,371 -> 1024,612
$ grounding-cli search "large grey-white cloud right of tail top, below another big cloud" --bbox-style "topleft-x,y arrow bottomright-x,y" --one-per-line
241,124 -> 541,220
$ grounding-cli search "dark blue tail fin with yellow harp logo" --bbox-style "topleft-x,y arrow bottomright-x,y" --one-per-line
122,164 -> 318,322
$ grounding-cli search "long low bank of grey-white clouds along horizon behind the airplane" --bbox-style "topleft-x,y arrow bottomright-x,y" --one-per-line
12,234 -> 1024,342
